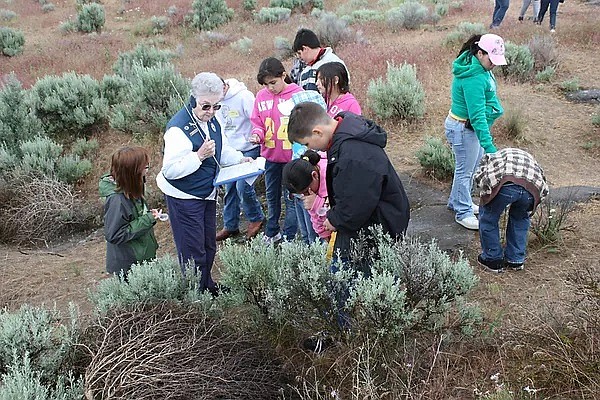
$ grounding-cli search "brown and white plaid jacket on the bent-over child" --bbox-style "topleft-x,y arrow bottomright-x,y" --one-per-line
475,148 -> 548,210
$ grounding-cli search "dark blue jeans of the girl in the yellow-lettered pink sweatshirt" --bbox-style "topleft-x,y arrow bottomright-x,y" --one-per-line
265,161 -> 298,240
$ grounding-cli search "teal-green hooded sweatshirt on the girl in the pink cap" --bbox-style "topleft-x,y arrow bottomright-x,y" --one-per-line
450,51 -> 504,153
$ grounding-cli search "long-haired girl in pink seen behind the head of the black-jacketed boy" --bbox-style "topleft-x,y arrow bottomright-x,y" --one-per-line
317,62 -> 362,117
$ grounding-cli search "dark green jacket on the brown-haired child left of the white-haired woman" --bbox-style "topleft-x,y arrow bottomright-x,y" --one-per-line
99,174 -> 158,273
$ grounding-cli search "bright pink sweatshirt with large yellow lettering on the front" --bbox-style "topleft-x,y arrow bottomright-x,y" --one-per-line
250,83 -> 302,163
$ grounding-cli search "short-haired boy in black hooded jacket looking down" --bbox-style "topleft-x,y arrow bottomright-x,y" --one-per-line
288,102 -> 410,261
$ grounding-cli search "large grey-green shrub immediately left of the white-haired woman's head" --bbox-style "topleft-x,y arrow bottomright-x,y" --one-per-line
110,64 -> 189,136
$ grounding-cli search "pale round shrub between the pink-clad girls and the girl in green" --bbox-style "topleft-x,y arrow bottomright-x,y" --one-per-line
367,62 -> 425,120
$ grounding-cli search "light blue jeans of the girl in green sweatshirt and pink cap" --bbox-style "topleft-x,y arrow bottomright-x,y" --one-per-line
444,117 -> 483,220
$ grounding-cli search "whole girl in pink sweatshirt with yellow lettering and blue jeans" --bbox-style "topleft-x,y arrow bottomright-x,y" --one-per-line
249,57 -> 302,243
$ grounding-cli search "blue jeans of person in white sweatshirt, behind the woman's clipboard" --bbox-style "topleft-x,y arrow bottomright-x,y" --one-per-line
223,147 -> 265,231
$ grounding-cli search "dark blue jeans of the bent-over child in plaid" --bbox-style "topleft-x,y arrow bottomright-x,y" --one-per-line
479,184 -> 534,264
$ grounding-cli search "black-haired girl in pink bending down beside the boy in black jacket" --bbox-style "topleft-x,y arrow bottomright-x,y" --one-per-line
283,150 -> 331,241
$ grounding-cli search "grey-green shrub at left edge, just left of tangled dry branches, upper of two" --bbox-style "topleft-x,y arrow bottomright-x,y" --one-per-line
0,305 -> 79,380
